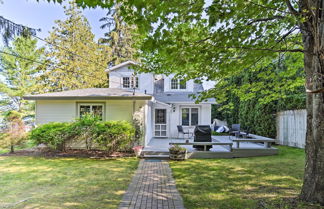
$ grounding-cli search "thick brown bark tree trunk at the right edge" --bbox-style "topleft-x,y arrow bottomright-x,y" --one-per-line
301,12 -> 324,205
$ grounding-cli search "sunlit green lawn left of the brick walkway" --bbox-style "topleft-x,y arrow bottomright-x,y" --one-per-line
0,157 -> 138,209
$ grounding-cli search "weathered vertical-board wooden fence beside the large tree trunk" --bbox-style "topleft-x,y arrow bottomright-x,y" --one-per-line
277,110 -> 306,148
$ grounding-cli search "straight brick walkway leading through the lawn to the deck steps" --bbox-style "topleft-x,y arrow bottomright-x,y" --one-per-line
119,159 -> 184,209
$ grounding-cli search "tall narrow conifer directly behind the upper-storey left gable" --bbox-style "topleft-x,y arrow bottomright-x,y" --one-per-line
99,5 -> 136,66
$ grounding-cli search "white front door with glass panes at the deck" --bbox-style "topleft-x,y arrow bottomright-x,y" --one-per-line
154,109 -> 168,137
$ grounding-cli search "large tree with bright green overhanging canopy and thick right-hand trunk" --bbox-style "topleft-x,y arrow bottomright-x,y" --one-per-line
43,0 -> 324,205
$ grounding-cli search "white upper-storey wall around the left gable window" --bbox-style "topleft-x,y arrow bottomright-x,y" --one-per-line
109,66 -> 154,94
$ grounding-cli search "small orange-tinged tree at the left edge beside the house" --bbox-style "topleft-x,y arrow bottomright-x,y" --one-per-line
0,110 -> 26,153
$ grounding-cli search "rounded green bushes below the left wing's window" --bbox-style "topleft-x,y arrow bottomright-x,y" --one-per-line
29,115 -> 135,154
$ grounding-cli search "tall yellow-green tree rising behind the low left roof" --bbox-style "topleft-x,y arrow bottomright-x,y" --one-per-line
39,2 -> 110,91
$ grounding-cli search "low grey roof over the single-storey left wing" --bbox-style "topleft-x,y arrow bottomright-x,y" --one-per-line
24,88 -> 152,100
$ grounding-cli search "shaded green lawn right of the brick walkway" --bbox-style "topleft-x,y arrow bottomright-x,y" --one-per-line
170,146 -> 318,209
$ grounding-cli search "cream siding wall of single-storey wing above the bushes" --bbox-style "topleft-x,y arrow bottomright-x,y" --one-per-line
36,100 -> 145,124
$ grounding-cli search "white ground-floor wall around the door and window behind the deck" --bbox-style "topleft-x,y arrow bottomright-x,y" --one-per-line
152,103 -> 211,138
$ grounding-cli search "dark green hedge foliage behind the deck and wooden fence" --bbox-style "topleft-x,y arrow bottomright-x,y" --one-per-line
213,56 -> 306,138
